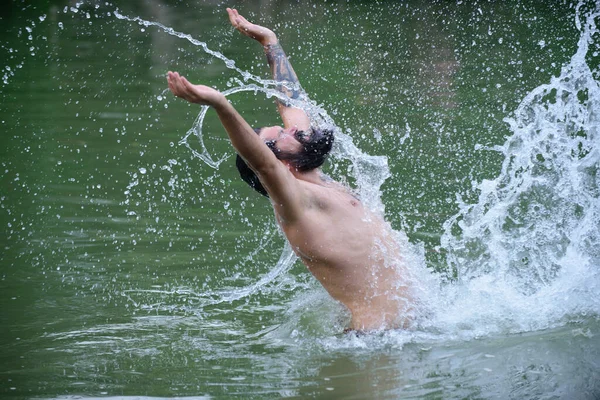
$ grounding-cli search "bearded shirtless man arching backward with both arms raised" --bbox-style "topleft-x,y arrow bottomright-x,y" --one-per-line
168,9 -> 410,331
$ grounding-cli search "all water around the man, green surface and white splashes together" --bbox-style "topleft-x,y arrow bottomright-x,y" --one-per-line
0,1 -> 600,399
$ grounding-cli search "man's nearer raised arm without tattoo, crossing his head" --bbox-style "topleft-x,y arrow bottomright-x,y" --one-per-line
167,71 -> 303,221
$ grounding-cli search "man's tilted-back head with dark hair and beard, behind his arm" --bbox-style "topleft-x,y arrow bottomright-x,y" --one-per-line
236,126 -> 333,197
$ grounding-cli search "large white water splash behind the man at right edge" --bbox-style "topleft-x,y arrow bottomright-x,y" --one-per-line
442,3 -> 600,331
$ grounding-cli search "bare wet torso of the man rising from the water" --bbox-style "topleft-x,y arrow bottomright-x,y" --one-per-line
278,182 -> 405,330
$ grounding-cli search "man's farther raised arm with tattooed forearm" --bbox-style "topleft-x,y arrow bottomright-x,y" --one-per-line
227,8 -> 310,130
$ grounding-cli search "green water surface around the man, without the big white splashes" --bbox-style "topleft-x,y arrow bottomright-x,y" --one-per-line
0,0 -> 600,399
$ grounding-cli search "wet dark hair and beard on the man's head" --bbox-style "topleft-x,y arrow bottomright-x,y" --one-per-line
235,128 -> 333,197
